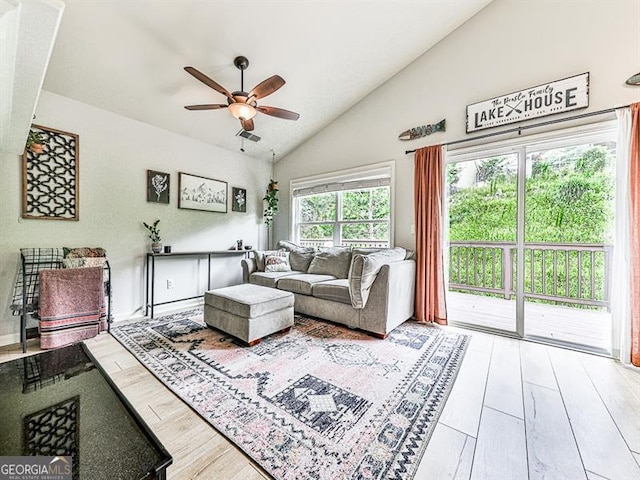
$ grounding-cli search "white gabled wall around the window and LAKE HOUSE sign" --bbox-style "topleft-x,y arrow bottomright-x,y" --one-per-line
275,0 -> 640,248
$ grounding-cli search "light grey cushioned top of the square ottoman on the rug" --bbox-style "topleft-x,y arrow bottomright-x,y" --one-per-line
204,283 -> 293,318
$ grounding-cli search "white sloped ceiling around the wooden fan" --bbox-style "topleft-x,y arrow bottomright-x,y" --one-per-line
44,0 -> 491,159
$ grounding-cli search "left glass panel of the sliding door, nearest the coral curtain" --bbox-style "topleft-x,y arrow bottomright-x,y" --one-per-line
447,153 -> 518,332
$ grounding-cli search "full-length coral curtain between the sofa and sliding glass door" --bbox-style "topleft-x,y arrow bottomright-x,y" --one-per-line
414,145 -> 447,325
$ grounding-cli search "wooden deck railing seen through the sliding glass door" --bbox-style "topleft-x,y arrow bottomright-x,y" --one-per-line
449,241 -> 613,309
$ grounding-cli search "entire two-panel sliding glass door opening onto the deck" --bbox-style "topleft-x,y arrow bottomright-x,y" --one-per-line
445,125 -> 615,353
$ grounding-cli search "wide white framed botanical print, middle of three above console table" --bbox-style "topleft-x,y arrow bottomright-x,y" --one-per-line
178,172 -> 227,213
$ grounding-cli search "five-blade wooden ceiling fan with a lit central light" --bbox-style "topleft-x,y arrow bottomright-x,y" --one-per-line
184,56 -> 300,132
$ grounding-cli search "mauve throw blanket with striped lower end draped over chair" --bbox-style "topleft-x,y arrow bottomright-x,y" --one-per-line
39,267 -> 104,349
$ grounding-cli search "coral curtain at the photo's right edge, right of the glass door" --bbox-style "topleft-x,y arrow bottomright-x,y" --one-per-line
629,103 -> 640,367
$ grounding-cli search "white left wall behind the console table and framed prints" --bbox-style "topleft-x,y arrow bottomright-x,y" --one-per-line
0,91 -> 271,345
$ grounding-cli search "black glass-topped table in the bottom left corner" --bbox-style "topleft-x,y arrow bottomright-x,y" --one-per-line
0,344 -> 172,480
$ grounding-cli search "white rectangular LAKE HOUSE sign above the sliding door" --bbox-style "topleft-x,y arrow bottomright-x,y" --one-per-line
467,72 -> 589,133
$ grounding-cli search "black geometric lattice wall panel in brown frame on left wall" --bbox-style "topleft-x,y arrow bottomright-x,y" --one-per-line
22,125 -> 79,220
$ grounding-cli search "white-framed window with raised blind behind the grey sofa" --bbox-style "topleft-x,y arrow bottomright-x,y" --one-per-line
292,167 -> 391,247
